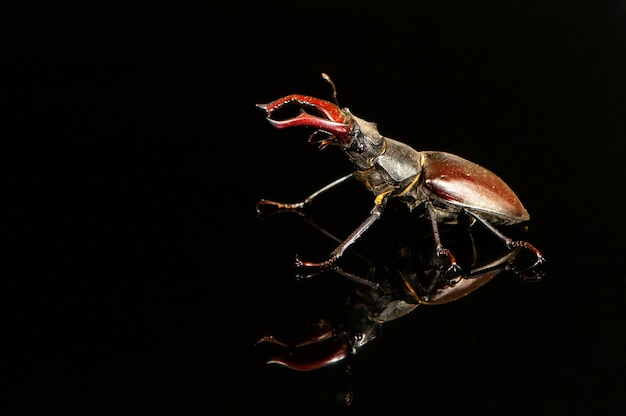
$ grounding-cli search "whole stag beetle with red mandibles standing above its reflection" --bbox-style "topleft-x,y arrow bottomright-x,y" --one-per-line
256,73 -> 545,275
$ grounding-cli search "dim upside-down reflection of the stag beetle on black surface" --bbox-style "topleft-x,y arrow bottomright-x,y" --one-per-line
257,223 -> 544,371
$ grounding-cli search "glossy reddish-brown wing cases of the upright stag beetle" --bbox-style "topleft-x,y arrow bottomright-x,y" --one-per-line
420,152 -> 530,224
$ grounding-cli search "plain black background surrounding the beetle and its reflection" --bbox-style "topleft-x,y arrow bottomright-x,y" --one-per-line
0,0 -> 626,415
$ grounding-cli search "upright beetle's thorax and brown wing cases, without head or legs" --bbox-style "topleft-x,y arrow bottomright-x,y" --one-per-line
346,124 -> 530,225
